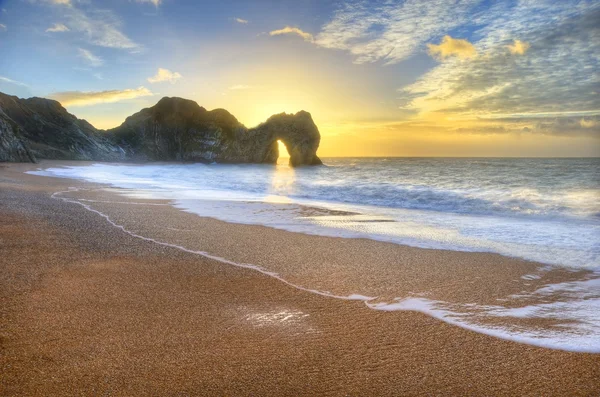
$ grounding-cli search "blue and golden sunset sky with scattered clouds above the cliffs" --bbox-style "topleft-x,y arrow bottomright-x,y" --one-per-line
0,0 -> 600,157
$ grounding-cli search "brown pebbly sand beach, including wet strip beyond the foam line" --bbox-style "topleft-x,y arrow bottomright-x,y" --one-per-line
0,162 -> 600,396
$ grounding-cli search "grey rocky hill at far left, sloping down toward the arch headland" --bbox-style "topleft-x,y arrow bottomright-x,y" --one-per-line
0,93 -> 125,161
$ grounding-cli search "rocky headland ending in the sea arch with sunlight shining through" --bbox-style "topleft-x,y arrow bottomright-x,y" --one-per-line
108,97 -> 322,166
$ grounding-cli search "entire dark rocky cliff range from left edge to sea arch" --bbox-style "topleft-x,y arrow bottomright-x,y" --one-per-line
0,93 -> 321,166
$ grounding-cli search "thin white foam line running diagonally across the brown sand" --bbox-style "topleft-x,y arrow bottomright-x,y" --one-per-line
51,187 -> 600,353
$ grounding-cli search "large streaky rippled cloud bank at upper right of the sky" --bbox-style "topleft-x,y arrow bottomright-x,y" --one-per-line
400,1 -> 600,134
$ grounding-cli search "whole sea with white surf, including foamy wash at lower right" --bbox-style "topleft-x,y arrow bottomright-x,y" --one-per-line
34,158 -> 600,351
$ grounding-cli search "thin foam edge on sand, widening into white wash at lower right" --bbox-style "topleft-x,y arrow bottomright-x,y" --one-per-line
47,188 -> 600,353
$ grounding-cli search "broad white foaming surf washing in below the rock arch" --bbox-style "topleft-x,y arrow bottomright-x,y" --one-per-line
28,160 -> 600,269
